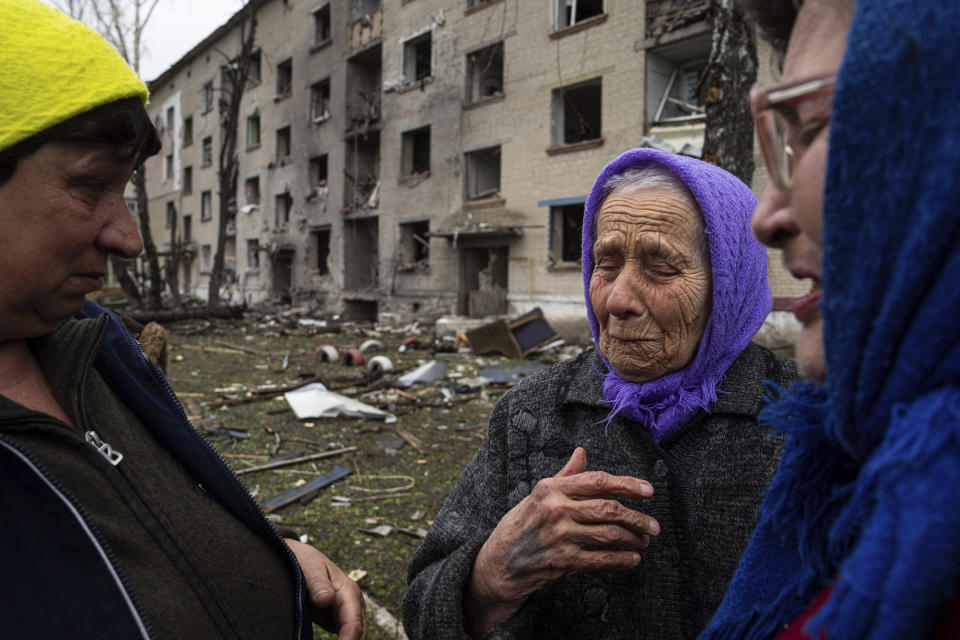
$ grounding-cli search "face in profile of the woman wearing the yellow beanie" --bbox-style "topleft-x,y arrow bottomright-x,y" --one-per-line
0,142 -> 142,341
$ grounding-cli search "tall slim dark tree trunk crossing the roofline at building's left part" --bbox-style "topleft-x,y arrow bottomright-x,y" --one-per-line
207,0 -> 258,309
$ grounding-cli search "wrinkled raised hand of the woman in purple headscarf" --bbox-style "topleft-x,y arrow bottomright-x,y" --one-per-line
464,447 -> 660,638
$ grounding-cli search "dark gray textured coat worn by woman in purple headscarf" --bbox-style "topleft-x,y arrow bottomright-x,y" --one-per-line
403,343 -> 797,640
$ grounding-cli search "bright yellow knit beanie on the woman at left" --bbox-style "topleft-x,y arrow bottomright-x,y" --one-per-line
0,0 -> 148,151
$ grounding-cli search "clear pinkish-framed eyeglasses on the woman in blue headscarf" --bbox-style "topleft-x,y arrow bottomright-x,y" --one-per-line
750,74 -> 837,193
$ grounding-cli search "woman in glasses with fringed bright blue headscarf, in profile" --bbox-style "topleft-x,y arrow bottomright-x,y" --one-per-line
701,0 -> 960,640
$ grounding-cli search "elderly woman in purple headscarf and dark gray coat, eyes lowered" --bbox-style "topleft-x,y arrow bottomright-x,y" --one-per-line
404,149 -> 795,640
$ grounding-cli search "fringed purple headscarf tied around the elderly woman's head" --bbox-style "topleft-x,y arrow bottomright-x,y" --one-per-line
582,149 -> 773,442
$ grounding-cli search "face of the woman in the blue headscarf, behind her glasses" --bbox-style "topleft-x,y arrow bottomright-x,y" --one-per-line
753,2 -> 849,382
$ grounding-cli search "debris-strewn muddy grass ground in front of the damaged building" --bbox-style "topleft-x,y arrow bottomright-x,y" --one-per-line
160,314 -> 584,640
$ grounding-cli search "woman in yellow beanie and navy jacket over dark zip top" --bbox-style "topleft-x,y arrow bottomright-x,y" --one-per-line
0,0 -> 364,640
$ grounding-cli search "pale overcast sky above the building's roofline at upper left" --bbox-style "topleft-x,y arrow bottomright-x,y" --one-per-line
42,0 -> 243,81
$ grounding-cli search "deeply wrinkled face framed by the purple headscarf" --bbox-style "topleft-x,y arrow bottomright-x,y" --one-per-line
590,189 -> 713,382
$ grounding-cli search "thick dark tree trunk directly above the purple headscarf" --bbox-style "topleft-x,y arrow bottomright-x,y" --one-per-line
701,0 -> 757,185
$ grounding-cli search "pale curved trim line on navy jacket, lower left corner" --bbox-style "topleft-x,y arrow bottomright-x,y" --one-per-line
0,432 -> 154,640
